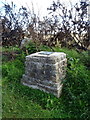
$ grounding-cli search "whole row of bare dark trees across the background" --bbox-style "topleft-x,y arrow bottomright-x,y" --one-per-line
0,1 -> 90,50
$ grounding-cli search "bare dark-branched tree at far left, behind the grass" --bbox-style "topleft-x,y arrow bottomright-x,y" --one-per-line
1,2 -> 30,46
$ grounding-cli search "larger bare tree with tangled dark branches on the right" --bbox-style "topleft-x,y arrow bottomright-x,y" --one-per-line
48,1 -> 90,49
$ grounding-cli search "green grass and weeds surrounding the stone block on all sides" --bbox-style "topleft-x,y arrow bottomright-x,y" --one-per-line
2,44 -> 90,120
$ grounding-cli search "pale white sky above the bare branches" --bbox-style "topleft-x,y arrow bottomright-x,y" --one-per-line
0,0 -> 80,19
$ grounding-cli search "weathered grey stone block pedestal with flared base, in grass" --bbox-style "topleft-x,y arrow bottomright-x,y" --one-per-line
21,51 -> 67,98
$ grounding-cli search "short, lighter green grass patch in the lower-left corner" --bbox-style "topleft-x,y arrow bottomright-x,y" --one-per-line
3,78 -> 53,118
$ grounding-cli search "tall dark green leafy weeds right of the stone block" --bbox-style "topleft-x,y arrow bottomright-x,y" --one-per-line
63,58 -> 90,118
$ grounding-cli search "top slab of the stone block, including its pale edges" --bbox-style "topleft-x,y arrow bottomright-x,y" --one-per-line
26,51 -> 66,64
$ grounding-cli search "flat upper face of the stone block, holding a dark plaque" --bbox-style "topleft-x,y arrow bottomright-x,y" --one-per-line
27,51 -> 66,58
